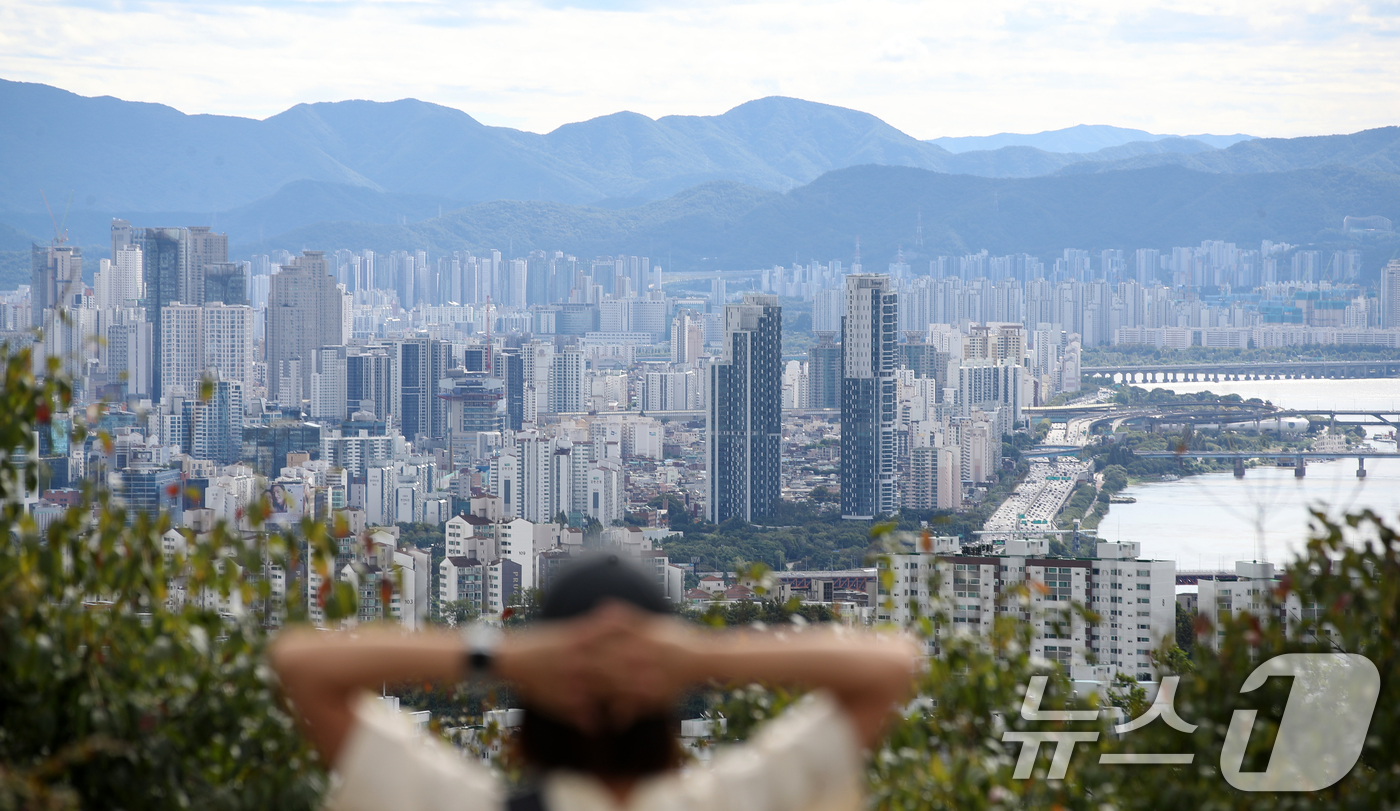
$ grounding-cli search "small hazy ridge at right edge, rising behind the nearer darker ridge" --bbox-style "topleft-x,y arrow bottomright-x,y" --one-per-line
1063,126 -> 1400,174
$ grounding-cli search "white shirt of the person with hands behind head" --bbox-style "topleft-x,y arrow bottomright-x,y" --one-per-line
329,693 -> 864,811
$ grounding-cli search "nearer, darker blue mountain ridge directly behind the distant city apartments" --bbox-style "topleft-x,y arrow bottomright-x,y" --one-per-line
234,167 -> 1400,270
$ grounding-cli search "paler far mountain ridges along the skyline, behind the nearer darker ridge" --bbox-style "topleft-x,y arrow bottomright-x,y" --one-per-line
0,81 -> 1400,262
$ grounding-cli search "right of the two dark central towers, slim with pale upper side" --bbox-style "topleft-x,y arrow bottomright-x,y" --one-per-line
841,275 -> 899,520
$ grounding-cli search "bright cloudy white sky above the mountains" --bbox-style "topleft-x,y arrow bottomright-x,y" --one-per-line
0,0 -> 1400,139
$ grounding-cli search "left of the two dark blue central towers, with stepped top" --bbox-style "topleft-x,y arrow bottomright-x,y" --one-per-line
706,293 -> 783,524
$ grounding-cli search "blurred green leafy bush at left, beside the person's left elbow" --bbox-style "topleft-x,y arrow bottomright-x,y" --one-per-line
0,341 -> 329,808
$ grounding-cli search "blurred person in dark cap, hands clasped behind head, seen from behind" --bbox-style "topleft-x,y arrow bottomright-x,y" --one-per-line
270,556 -> 920,811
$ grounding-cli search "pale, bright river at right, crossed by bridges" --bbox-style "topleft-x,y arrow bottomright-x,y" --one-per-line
1099,378 -> 1400,570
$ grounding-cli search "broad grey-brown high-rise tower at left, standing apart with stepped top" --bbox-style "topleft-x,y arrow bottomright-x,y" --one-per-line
267,251 -> 344,399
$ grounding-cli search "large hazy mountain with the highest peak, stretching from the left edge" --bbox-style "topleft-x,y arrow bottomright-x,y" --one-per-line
0,81 -> 946,216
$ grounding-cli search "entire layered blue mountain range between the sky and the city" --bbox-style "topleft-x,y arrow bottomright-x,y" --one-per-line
0,80 -> 1400,278
